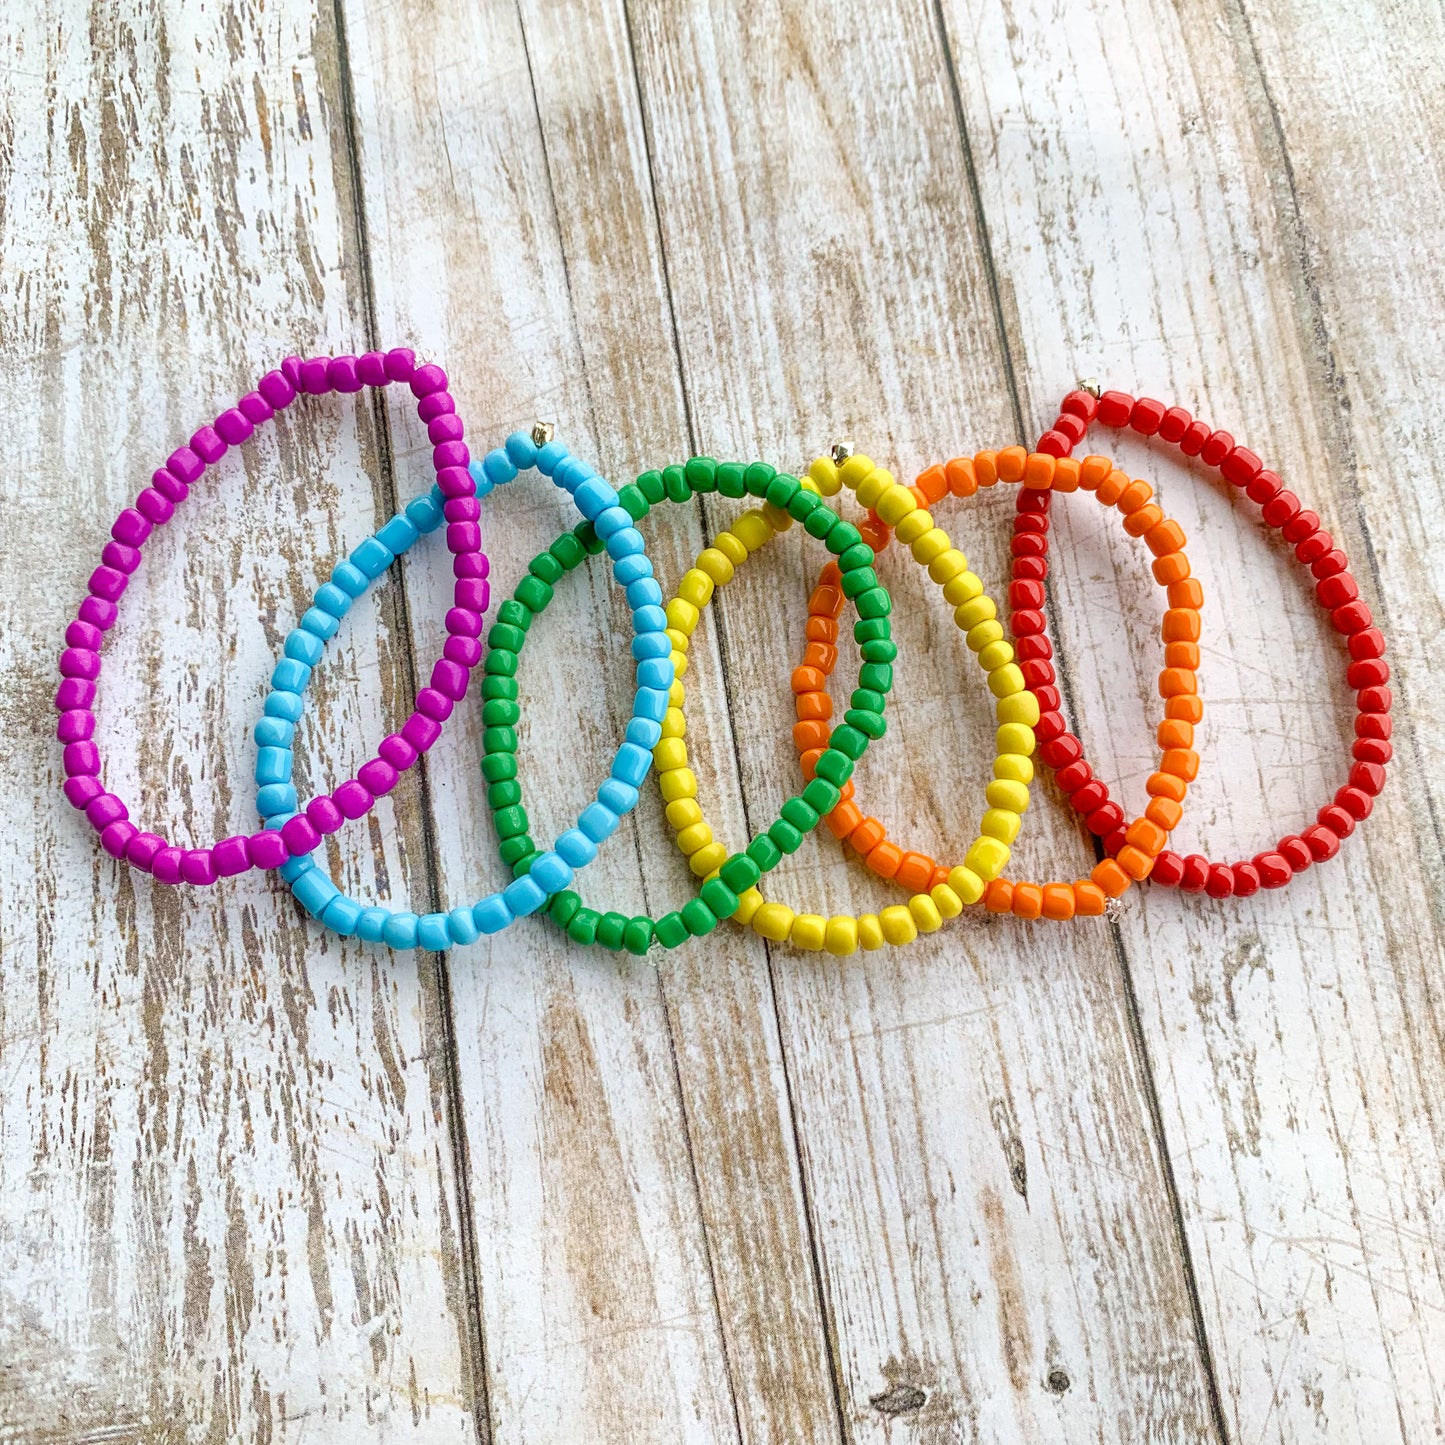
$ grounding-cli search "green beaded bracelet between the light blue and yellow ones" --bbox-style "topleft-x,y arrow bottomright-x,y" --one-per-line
481,457 -> 893,955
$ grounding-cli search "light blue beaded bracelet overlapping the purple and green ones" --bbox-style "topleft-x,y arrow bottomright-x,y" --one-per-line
256,432 -> 673,951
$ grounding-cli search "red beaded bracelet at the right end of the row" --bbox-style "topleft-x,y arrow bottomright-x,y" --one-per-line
1028,387 -> 1392,897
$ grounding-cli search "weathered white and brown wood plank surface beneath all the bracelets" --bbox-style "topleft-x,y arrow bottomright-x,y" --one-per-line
0,0 -> 1445,1445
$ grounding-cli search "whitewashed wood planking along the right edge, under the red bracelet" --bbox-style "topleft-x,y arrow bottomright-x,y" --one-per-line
944,0 -> 1445,1441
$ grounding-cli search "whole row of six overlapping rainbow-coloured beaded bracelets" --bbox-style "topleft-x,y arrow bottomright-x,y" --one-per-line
56,358 -> 1392,955
